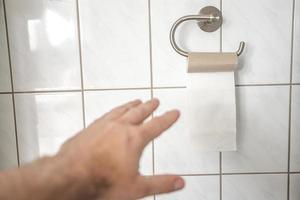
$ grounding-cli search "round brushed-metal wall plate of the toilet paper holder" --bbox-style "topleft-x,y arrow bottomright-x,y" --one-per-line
197,6 -> 223,32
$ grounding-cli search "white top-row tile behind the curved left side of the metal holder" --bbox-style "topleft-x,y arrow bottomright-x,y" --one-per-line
151,0 -> 220,86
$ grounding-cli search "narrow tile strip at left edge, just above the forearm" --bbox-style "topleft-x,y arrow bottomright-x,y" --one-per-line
0,94 -> 18,170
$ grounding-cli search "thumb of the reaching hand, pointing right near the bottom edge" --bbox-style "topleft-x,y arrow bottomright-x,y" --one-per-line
138,175 -> 185,198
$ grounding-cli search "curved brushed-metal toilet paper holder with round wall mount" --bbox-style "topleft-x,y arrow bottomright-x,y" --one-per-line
170,6 -> 245,57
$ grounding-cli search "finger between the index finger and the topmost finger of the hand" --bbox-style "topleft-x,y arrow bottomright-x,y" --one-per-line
122,99 -> 159,124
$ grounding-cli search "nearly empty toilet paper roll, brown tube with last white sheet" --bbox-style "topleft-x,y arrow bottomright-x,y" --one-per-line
186,53 -> 237,152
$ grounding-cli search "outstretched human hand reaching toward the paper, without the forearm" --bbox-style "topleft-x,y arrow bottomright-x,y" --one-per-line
56,99 -> 184,200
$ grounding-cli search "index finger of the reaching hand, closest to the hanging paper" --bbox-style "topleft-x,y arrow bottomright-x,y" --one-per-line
141,110 -> 180,146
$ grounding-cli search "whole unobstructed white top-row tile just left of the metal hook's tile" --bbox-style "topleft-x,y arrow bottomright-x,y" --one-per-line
80,0 -> 150,88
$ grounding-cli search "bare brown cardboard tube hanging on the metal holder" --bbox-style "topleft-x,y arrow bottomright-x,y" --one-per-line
188,53 -> 238,73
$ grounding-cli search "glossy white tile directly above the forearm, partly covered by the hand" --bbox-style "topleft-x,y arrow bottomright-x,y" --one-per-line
15,93 -> 83,163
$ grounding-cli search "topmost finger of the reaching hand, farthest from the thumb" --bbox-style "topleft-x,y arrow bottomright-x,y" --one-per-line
104,99 -> 142,120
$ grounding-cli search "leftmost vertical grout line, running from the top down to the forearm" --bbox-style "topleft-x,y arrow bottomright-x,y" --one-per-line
3,0 -> 20,166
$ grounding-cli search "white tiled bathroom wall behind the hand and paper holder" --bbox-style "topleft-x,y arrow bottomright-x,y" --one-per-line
0,0 -> 300,200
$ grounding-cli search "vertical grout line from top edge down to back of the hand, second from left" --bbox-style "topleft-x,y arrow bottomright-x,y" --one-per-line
76,0 -> 86,128
